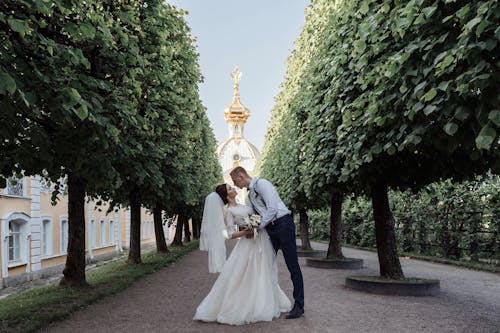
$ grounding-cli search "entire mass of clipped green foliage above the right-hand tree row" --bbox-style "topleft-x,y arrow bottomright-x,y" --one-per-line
261,0 -> 500,203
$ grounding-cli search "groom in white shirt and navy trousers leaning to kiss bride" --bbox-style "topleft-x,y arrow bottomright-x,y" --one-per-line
230,167 -> 304,319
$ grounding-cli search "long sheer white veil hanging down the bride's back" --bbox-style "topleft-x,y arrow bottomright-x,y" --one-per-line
200,192 -> 226,273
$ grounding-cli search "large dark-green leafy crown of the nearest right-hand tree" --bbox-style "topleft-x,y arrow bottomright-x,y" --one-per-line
304,0 -> 500,188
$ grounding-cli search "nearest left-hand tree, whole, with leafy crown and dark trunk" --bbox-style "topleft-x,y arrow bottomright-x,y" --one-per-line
2,1 -> 137,285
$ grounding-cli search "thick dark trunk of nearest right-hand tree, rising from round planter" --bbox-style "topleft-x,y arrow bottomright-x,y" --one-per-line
371,179 -> 404,279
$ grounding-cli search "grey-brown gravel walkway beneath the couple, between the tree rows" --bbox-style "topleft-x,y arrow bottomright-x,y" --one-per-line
43,243 -> 500,333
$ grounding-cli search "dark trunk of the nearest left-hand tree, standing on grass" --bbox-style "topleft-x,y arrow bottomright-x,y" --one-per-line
60,174 -> 88,286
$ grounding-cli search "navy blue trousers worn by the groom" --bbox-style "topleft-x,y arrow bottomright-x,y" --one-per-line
266,215 -> 304,308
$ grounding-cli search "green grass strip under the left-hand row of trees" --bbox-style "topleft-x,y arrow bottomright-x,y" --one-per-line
0,241 -> 198,333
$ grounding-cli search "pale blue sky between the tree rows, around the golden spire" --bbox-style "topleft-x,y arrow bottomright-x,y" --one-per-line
167,0 -> 309,151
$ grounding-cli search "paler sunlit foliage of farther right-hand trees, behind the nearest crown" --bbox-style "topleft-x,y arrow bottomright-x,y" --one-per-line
257,0 -> 333,209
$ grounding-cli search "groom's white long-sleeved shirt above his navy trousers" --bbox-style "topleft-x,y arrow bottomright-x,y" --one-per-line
248,177 -> 290,229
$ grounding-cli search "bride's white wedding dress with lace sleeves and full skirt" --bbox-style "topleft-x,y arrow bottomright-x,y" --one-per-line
193,205 -> 291,325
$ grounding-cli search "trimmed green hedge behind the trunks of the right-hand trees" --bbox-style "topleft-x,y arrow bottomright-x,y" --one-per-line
324,175 -> 500,260
